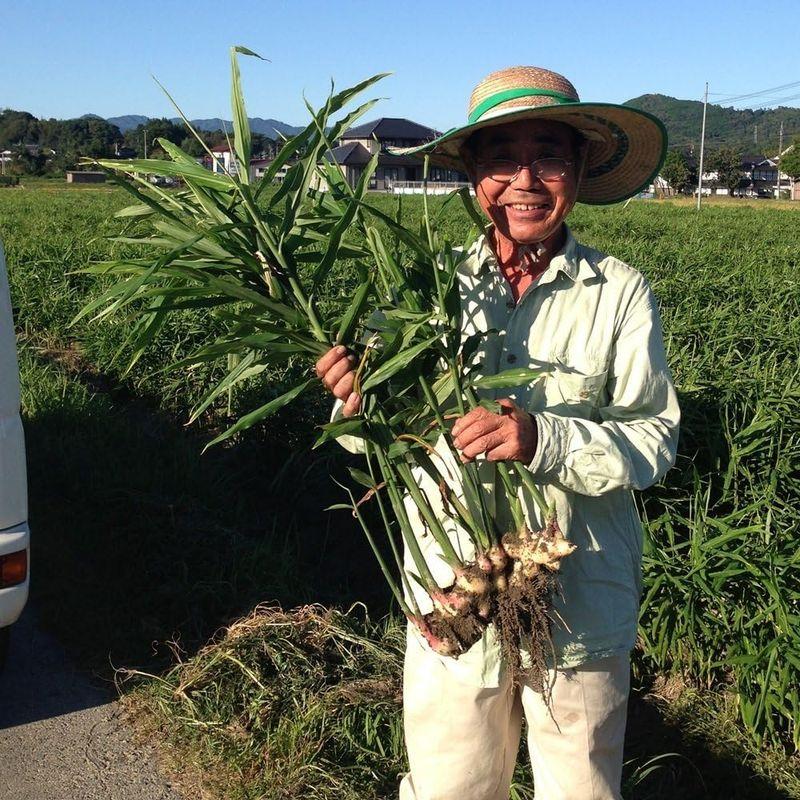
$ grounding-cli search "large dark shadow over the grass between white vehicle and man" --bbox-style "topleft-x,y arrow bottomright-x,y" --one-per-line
22,346 -> 388,677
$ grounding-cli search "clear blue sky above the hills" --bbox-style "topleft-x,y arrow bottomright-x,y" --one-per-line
0,0 -> 800,129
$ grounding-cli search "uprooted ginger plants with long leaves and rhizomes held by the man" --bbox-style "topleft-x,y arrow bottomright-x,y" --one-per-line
80,47 -> 573,683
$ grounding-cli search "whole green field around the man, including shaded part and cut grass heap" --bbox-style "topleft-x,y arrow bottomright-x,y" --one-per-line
0,183 -> 800,798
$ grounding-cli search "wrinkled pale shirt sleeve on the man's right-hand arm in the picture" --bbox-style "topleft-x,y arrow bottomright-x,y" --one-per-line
529,279 -> 680,496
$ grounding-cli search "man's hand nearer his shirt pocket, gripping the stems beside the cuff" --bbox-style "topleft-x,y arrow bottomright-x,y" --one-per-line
453,399 -> 538,464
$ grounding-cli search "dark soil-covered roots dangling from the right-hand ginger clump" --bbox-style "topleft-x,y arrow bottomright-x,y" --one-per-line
494,568 -> 558,695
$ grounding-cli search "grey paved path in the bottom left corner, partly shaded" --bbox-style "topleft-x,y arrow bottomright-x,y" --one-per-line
0,607 -> 179,800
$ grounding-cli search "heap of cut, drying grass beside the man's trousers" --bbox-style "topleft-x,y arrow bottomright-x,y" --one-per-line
127,606 -> 404,800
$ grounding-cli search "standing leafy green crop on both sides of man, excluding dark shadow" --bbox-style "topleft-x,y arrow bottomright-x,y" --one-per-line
0,191 -> 800,747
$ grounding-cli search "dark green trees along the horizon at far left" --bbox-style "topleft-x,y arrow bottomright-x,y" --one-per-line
0,109 -> 279,175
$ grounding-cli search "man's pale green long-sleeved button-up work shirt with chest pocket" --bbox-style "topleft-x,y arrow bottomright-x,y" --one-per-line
340,229 -> 680,686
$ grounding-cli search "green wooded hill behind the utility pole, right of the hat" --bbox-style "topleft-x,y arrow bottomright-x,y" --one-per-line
624,94 -> 800,156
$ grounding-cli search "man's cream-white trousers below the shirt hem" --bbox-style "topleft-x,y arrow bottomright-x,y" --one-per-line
400,637 -> 630,800
